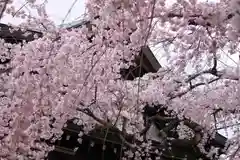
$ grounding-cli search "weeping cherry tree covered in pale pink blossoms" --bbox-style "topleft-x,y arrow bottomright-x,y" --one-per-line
0,0 -> 240,160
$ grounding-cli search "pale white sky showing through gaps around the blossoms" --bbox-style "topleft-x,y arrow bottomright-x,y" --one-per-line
1,0 -> 238,136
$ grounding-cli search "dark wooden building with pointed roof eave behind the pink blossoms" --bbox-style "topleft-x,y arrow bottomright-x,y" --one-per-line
0,22 -> 227,160
